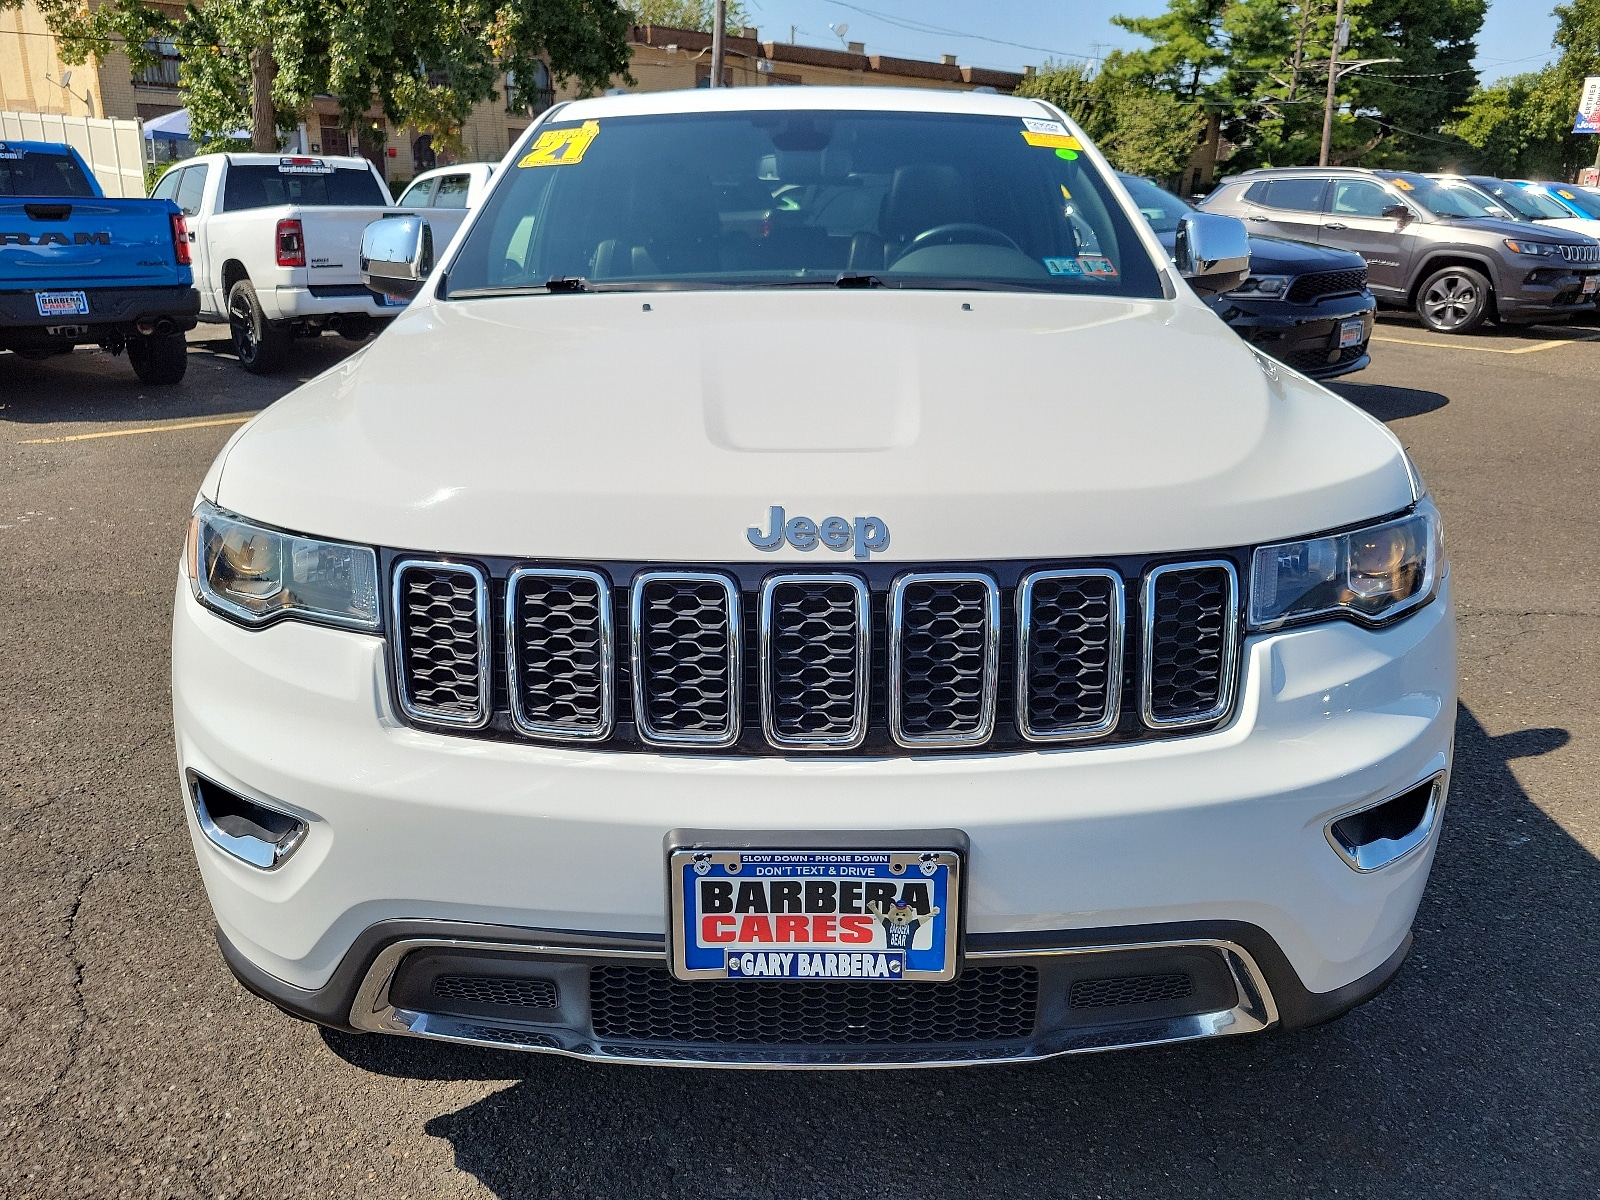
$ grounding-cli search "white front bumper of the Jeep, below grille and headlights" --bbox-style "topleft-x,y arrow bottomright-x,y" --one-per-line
173,578 -> 1456,1066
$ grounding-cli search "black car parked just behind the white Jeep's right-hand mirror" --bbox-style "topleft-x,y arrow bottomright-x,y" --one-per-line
1117,173 -> 1378,379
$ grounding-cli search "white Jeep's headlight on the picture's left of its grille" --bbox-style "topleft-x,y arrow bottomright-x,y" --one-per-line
189,501 -> 379,632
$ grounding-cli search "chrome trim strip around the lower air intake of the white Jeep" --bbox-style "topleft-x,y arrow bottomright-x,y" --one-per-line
350,938 -> 1278,1070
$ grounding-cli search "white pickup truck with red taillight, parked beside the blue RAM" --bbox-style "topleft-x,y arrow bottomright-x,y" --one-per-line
152,154 -> 466,374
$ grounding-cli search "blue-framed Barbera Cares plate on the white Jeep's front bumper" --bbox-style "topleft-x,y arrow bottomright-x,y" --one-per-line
667,846 -> 962,982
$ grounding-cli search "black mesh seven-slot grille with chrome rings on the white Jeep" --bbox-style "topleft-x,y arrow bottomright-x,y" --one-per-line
389,558 -> 1240,755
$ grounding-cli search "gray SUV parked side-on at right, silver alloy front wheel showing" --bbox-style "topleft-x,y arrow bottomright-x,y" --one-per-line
1200,166 -> 1600,333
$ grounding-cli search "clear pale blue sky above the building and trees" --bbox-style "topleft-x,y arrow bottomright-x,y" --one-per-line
744,0 -> 1555,80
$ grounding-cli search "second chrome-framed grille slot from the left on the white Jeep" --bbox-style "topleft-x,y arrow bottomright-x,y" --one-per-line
506,566 -> 616,742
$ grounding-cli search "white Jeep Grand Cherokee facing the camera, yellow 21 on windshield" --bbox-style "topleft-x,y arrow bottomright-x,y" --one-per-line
173,88 -> 1456,1066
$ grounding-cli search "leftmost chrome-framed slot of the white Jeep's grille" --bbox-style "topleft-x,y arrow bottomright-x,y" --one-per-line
389,558 -> 494,730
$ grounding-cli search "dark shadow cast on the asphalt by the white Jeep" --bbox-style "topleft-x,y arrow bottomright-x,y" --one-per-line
325,707 -> 1600,1200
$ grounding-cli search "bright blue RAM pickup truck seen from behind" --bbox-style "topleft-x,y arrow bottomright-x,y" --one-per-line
0,141 -> 200,384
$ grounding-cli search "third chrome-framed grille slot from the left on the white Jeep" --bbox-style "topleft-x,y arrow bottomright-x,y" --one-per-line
629,571 -> 744,749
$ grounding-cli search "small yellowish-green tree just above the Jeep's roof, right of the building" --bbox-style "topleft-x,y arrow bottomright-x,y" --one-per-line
1018,54 -> 1200,181
